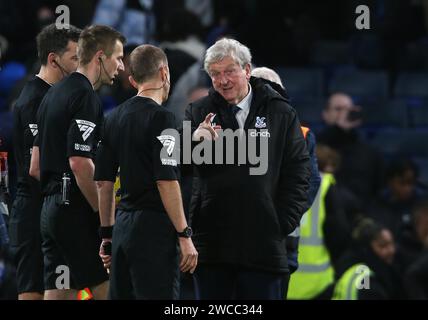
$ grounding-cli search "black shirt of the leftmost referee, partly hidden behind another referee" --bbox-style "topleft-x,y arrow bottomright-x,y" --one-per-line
13,76 -> 51,196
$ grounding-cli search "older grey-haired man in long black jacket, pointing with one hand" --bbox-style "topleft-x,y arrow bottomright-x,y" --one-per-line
185,38 -> 310,299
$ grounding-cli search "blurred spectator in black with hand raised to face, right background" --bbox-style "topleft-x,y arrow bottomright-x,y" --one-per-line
318,93 -> 383,208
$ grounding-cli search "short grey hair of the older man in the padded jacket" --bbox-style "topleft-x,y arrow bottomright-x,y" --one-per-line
204,38 -> 251,74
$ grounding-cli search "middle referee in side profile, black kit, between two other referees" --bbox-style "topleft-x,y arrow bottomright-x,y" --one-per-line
30,26 -> 125,299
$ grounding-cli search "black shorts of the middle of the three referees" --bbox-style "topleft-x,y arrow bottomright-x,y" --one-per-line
40,193 -> 108,290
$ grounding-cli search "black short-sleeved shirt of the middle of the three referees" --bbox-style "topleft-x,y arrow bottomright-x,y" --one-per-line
35,72 -> 103,195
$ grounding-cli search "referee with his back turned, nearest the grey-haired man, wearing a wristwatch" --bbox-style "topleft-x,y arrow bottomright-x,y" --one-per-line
95,45 -> 197,299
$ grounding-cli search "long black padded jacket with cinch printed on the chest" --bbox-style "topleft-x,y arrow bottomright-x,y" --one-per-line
185,78 -> 310,273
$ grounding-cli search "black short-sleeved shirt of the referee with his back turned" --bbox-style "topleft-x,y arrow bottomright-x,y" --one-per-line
95,96 -> 179,211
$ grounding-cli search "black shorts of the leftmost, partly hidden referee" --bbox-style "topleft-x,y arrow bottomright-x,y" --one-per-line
9,195 -> 44,294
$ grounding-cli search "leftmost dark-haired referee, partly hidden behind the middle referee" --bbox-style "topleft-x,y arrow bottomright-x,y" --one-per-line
9,24 -> 81,300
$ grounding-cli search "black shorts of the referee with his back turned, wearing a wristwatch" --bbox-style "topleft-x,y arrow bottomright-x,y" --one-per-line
110,210 -> 179,300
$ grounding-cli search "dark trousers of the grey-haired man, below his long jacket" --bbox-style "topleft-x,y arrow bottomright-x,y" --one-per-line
195,265 -> 289,300
